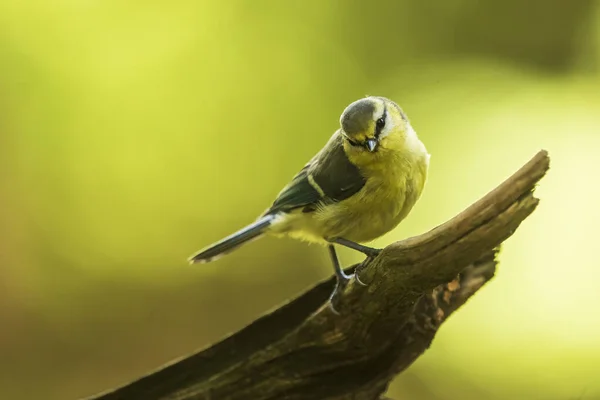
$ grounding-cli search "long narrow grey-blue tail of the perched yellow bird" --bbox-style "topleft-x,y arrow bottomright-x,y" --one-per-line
188,215 -> 274,264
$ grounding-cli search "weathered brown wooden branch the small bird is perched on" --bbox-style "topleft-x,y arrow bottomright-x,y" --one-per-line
90,151 -> 549,400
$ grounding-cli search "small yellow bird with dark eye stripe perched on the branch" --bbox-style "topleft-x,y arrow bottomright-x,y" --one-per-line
189,96 -> 430,312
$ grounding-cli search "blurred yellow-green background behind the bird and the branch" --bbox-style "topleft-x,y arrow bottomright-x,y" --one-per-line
0,0 -> 600,400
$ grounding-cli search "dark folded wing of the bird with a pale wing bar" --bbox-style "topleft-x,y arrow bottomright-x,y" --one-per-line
266,132 -> 366,214
